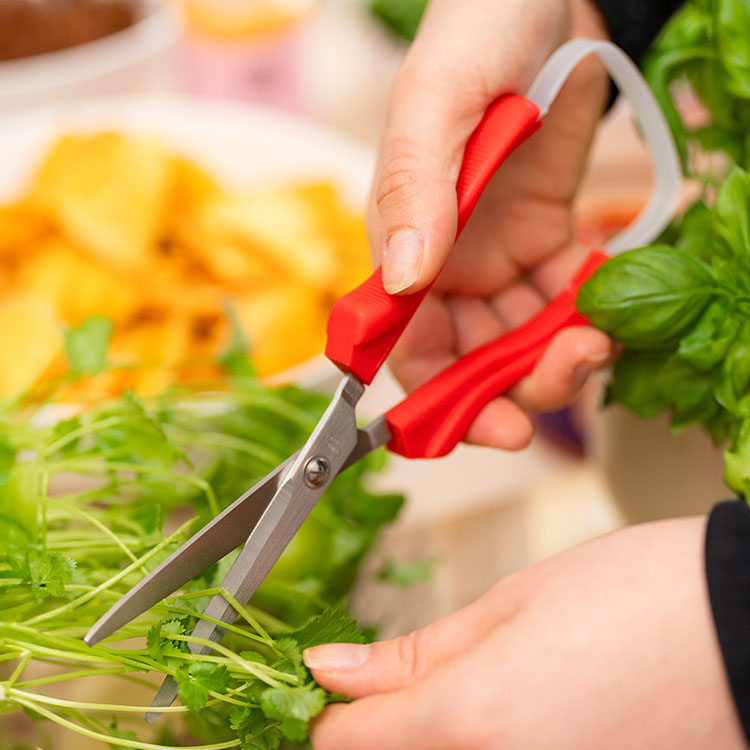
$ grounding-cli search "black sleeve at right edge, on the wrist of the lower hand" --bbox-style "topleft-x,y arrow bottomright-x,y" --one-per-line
706,500 -> 750,742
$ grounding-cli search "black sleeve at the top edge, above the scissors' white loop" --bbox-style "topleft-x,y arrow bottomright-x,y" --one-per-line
596,0 -> 684,62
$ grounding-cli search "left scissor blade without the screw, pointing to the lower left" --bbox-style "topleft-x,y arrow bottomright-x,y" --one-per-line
84,451 -> 299,646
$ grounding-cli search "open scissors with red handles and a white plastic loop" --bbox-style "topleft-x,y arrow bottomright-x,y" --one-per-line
85,39 -> 680,720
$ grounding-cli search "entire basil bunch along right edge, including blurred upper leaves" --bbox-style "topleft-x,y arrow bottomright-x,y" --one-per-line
578,0 -> 750,500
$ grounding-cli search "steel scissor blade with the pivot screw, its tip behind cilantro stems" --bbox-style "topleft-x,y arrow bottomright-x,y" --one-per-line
148,375 -> 376,720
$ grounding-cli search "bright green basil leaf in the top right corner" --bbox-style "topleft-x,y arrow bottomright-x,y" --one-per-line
716,0 -> 750,99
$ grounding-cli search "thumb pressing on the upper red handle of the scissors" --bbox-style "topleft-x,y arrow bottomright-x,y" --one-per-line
369,0 -> 566,294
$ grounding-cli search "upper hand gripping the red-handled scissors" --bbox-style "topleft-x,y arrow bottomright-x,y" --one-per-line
368,0 -> 611,449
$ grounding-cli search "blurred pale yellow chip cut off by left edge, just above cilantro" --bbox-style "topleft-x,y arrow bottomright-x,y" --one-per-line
0,295 -> 63,398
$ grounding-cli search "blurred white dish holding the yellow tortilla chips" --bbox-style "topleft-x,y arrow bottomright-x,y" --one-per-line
0,97 -> 374,388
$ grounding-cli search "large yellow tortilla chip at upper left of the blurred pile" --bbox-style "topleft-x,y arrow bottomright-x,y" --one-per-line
30,133 -> 173,268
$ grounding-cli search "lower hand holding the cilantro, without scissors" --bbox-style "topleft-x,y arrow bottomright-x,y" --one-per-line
305,518 -> 745,750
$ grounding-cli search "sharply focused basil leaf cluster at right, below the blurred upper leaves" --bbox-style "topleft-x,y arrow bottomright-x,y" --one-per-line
578,168 -> 750,498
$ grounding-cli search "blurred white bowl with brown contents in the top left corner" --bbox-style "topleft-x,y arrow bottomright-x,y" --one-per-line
0,0 -> 179,113
